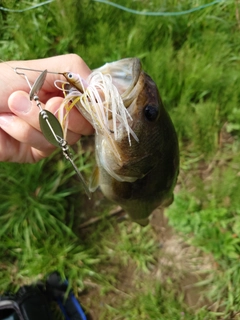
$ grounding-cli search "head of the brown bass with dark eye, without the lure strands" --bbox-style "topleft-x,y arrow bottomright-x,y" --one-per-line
94,58 -> 168,182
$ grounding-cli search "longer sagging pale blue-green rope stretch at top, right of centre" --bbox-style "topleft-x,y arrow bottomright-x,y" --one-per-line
93,0 -> 224,17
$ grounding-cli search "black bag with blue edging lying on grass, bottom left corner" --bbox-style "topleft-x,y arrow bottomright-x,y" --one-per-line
0,272 -> 87,320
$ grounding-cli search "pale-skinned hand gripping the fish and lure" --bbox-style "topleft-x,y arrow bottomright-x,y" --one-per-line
0,54 -> 94,163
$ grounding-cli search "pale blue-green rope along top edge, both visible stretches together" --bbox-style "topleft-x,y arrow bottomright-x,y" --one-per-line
0,0 -> 224,17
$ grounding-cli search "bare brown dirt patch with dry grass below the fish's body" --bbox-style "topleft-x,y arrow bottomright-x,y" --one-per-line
79,207 -> 214,320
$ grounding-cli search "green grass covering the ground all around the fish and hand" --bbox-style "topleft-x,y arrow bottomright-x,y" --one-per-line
0,0 -> 240,320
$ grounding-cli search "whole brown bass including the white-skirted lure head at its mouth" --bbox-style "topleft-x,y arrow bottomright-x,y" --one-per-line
61,58 -> 179,226
